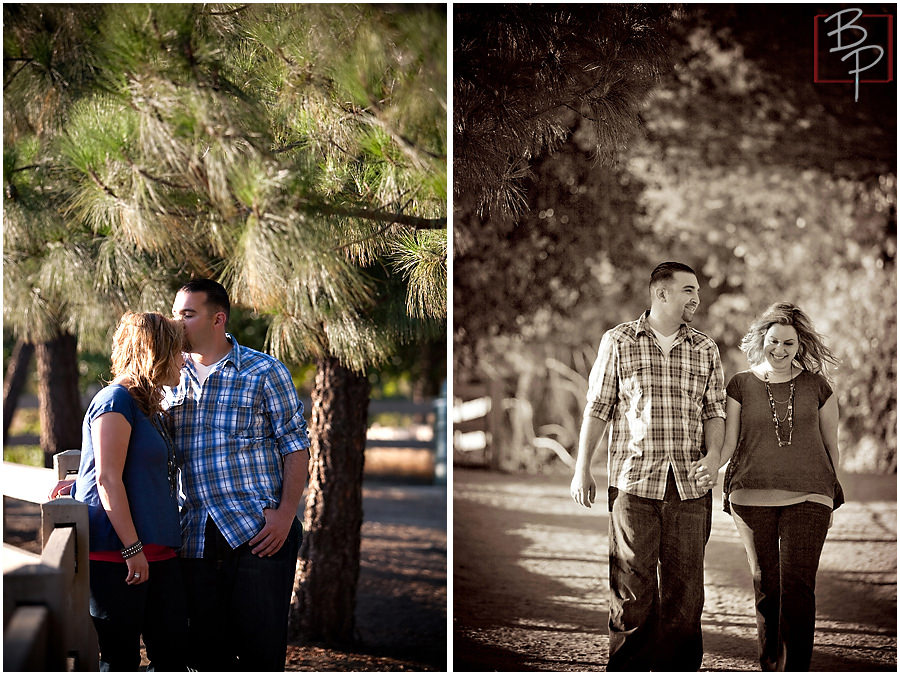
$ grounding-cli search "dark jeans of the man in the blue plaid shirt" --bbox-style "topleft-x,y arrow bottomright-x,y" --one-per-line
182,518 -> 302,672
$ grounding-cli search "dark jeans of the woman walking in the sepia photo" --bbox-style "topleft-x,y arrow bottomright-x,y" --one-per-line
731,502 -> 831,670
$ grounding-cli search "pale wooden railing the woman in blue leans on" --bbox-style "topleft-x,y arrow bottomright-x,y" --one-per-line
2,450 -> 99,672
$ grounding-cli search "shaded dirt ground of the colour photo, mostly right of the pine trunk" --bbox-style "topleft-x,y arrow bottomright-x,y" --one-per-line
3,479 -> 447,672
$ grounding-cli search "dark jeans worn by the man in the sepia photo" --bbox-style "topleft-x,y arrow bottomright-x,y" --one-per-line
607,471 -> 712,672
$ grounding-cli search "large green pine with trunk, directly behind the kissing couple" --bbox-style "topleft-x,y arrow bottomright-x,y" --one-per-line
4,5 -> 446,641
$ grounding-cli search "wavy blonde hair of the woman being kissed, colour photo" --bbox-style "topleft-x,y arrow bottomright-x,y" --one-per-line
112,312 -> 184,417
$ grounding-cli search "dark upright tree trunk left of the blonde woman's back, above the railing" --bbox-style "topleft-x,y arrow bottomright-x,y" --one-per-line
36,333 -> 82,467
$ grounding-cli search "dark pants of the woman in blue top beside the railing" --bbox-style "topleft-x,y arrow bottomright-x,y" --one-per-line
90,558 -> 187,672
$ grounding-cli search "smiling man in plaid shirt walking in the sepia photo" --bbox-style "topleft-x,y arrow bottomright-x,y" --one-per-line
571,262 -> 725,672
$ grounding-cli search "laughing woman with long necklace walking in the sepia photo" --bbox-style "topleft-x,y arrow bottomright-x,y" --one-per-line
700,303 -> 843,670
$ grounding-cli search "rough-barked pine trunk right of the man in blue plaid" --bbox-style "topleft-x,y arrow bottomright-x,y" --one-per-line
290,358 -> 369,644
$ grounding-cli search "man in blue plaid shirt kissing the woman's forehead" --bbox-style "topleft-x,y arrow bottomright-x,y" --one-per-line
166,280 -> 309,671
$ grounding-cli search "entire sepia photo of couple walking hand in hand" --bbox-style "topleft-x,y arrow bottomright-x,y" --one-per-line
451,3 -> 897,672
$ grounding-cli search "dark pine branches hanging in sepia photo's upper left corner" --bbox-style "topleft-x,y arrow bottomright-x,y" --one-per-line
453,3 -> 671,223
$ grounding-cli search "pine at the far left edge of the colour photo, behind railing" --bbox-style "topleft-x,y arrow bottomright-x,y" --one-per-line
3,3 -> 116,466
